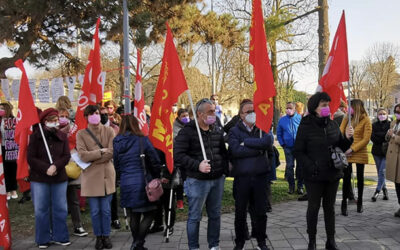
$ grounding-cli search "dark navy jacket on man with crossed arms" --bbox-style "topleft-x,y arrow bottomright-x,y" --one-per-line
229,122 -> 274,177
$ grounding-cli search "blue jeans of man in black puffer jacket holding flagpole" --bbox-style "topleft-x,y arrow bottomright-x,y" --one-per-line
184,176 -> 225,249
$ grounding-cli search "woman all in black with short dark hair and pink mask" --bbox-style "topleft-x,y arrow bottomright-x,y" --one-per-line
294,92 -> 354,250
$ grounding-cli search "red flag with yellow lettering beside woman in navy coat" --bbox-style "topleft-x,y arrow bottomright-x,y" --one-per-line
149,23 -> 188,173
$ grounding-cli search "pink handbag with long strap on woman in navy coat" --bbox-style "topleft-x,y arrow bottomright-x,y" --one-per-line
139,137 -> 164,202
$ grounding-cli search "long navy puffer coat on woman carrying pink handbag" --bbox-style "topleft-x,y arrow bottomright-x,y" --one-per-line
113,132 -> 161,208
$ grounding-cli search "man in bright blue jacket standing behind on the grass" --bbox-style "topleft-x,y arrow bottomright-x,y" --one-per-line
277,102 -> 304,194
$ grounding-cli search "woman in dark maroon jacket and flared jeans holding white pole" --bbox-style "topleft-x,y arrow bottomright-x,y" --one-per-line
28,108 -> 71,249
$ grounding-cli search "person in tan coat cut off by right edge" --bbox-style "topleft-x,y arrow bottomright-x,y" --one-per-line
386,104 -> 400,217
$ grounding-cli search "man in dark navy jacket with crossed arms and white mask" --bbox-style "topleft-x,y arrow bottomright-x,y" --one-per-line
228,101 -> 273,250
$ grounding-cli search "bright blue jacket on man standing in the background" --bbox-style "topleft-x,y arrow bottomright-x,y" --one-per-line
276,113 -> 301,148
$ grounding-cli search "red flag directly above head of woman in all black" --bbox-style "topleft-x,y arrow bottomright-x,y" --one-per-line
317,11 -> 349,114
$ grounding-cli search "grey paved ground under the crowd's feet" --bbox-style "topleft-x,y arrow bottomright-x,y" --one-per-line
13,165 -> 400,250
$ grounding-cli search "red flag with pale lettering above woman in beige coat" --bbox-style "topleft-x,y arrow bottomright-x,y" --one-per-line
75,18 -> 102,131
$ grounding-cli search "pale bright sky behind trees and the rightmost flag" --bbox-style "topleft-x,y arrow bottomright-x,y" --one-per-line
0,0 -> 400,93
